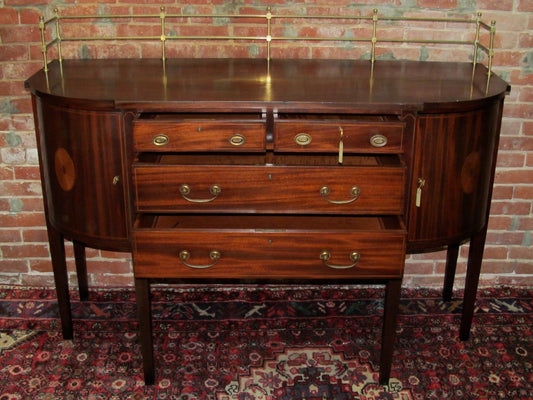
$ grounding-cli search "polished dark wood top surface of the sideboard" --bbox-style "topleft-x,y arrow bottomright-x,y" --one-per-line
26,58 -> 510,112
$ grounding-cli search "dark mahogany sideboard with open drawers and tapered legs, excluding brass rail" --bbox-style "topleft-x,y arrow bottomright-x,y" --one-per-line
26,7 -> 510,383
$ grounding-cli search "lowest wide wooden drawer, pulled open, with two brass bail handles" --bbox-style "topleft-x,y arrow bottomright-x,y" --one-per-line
133,215 -> 406,279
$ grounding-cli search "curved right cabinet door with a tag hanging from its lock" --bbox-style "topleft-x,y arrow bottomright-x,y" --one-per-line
409,100 -> 502,250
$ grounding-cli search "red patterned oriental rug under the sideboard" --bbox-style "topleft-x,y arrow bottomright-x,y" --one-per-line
0,285 -> 533,400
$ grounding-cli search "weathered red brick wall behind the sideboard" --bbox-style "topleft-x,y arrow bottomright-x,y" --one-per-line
0,0 -> 533,286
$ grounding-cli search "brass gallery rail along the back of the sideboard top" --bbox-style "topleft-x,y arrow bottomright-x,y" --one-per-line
39,7 -> 496,74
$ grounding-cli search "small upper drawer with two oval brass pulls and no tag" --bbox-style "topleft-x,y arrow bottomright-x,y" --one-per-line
133,114 -> 265,152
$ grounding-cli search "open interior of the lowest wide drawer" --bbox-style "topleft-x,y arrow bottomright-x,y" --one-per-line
135,214 -> 404,233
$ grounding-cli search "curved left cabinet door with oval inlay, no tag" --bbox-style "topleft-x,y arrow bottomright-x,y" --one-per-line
35,97 -> 129,251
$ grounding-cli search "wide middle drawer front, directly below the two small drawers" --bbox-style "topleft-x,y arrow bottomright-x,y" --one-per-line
133,159 -> 405,214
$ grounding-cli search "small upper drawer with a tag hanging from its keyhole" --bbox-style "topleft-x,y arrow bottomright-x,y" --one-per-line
274,117 -> 405,154
